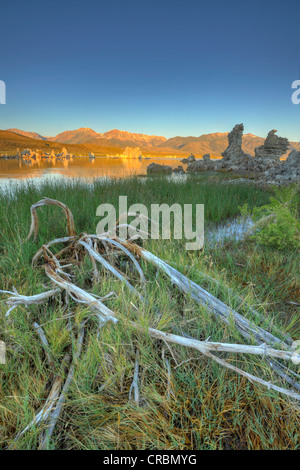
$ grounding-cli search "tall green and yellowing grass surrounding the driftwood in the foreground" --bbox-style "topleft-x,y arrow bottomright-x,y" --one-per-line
0,177 -> 300,450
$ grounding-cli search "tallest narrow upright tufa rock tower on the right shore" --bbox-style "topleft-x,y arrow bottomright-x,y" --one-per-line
222,124 -> 252,168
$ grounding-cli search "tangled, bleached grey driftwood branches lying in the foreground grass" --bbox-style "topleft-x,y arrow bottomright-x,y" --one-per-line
0,198 -> 300,449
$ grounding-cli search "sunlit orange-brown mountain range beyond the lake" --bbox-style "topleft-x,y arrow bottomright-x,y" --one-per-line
0,127 -> 300,157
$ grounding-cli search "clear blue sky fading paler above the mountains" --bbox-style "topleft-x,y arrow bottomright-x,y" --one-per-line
0,0 -> 300,141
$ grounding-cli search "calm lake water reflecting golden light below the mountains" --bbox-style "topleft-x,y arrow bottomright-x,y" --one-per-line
0,157 -> 186,188
